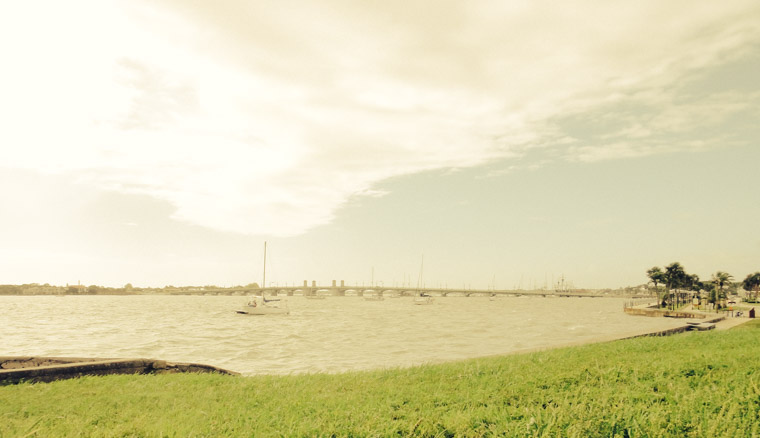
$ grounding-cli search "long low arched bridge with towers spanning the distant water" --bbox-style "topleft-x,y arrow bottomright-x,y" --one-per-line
177,280 -> 602,298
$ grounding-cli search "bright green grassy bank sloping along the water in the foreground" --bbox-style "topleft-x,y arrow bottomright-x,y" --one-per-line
0,324 -> 760,437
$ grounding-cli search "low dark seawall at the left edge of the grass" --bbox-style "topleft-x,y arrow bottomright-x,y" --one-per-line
0,356 -> 238,385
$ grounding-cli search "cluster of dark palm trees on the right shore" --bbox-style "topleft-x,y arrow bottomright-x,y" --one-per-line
647,262 -> 760,310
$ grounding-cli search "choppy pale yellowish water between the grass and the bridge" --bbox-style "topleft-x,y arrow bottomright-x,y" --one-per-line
0,295 -> 680,374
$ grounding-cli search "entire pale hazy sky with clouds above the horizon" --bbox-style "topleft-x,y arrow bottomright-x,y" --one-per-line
0,0 -> 760,289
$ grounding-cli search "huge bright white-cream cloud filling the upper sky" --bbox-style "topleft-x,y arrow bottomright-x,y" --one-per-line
0,0 -> 760,235
